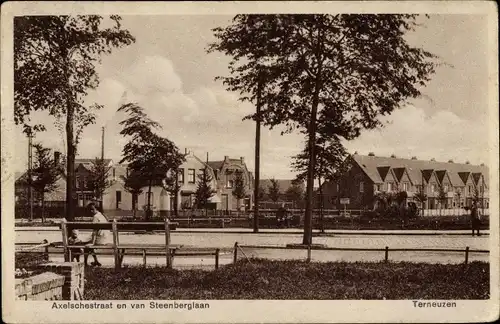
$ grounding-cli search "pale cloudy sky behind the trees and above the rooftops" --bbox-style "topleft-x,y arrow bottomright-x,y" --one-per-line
14,15 -> 489,179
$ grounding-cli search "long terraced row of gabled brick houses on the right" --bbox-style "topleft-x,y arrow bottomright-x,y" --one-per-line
323,153 -> 489,209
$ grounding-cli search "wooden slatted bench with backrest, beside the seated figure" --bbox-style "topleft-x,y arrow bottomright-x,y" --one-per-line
60,219 -> 179,269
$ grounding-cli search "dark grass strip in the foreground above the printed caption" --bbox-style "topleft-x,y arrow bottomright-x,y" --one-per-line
85,259 -> 490,300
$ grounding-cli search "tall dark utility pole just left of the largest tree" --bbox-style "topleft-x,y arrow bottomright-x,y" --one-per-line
253,71 -> 264,233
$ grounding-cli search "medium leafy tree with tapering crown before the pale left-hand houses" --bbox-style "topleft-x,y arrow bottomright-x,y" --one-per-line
118,103 -> 185,219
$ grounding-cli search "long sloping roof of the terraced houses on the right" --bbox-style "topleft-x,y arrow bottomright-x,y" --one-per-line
350,154 -> 489,186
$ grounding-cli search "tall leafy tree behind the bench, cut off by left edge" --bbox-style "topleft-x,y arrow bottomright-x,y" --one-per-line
14,15 -> 135,220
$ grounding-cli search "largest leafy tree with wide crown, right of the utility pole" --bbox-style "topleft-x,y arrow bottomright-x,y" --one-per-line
208,14 -> 436,244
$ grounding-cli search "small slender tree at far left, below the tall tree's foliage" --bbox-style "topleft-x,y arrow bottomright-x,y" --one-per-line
31,143 -> 61,222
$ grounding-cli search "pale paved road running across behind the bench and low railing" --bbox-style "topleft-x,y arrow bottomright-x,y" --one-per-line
16,230 -> 490,267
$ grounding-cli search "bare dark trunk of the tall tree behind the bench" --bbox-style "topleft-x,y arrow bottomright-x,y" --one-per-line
66,100 -> 75,221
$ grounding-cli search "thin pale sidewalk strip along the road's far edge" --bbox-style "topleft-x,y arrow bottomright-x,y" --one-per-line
15,226 -> 490,236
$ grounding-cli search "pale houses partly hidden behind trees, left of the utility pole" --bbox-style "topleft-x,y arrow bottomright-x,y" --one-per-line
16,152 -> 253,211
